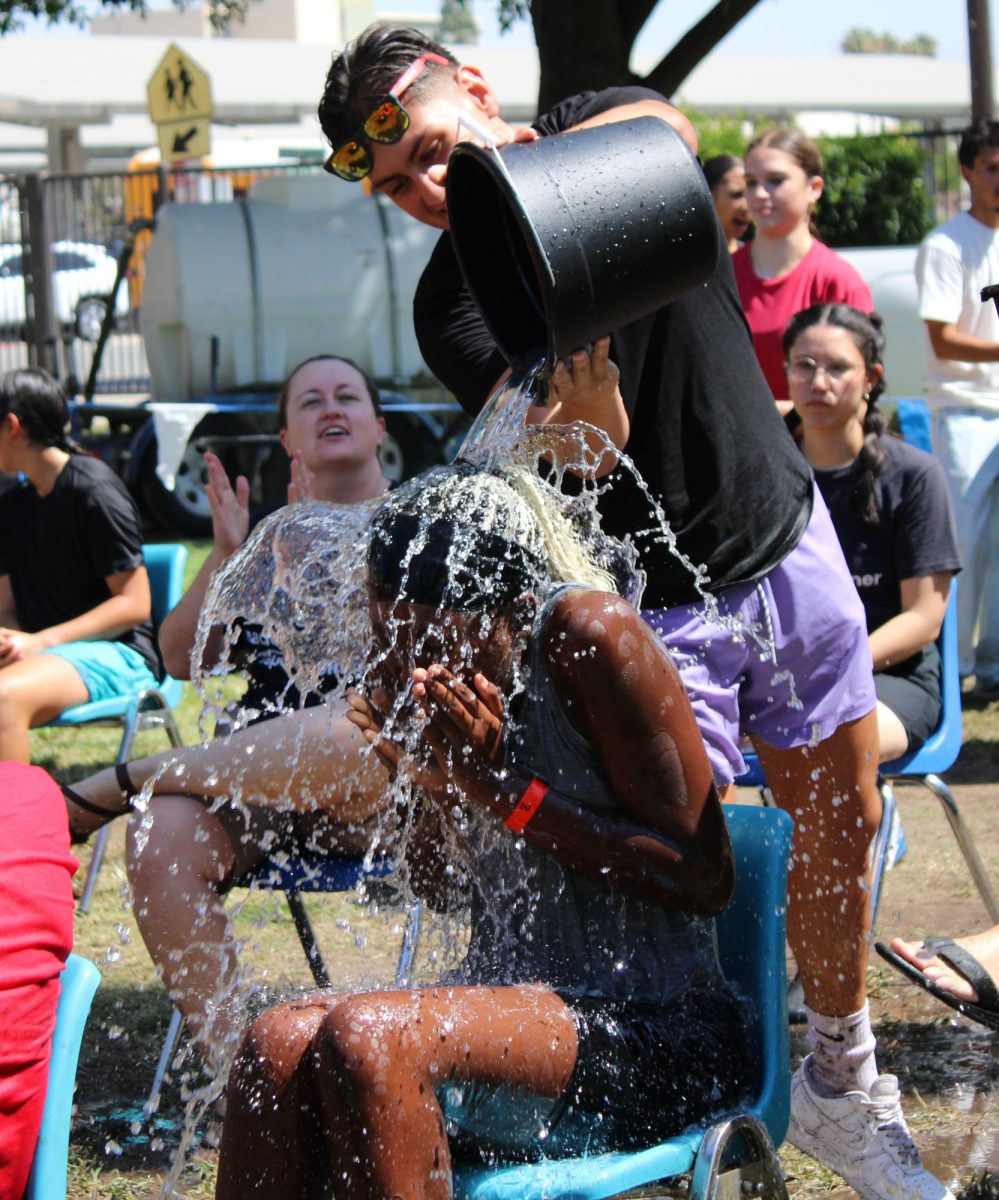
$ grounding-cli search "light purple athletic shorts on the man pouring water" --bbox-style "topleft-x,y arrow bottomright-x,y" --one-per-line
642,488 -> 875,787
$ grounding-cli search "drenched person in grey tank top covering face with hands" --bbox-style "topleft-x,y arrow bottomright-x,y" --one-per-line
217,464 -> 752,1198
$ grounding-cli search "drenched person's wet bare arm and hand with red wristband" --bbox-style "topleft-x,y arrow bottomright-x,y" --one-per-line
413,590 -> 735,914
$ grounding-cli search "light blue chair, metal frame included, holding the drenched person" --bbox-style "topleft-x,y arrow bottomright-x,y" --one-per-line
455,804 -> 791,1200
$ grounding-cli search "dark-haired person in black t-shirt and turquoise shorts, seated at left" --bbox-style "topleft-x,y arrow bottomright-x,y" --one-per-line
0,368 -> 162,763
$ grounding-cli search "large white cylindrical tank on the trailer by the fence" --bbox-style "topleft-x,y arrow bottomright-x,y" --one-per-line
140,175 -> 438,403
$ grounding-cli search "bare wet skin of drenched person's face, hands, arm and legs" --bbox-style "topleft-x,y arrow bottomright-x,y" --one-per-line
216,590 -> 734,1200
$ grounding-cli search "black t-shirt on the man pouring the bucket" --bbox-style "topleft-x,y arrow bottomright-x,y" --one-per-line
414,88 -> 812,608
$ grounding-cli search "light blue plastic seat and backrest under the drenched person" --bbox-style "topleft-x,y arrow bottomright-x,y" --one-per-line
455,804 -> 792,1200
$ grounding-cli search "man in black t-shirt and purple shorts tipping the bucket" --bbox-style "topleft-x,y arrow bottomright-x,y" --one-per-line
319,26 -> 950,1200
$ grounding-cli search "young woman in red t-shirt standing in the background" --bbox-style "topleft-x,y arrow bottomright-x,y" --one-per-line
732,128 -> 874,416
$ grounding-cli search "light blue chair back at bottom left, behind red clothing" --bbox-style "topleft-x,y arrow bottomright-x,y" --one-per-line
24,954 -> 101,1200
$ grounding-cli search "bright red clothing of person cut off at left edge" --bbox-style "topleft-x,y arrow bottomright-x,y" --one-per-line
0,761 -> 78,1200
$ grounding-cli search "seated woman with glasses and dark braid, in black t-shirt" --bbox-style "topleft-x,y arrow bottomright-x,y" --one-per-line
784,304 -> 961,762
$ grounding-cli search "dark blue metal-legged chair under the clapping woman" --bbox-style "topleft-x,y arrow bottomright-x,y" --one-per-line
145,854 -> 423,1114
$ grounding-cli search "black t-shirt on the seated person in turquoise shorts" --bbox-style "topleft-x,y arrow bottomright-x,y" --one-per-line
0,454 -> 163,678
